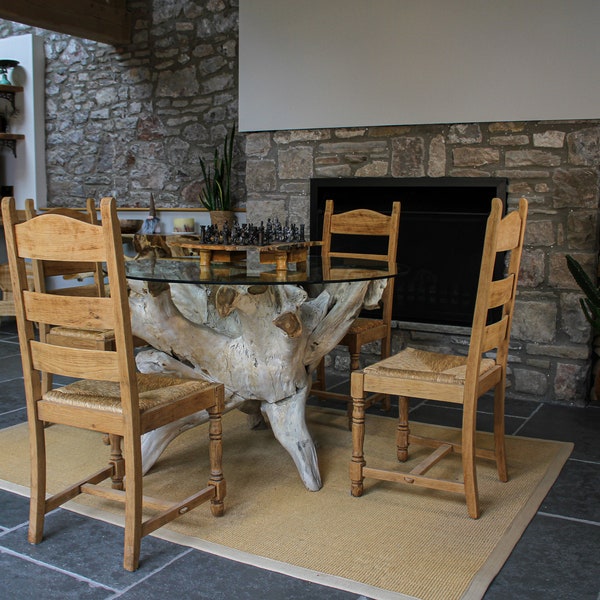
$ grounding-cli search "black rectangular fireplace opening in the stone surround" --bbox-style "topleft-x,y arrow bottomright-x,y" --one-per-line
310,177 -> 507,327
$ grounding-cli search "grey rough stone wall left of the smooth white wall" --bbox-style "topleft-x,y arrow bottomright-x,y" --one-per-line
0,0 -> 245,208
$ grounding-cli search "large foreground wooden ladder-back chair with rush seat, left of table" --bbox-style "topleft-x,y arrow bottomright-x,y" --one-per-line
2,198 -> 225,571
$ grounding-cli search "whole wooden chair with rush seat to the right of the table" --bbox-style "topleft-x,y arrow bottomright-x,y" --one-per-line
350,198 -> 527,519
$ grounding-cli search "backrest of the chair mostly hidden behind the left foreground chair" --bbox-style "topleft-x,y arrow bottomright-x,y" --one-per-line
25,198 -> 106,296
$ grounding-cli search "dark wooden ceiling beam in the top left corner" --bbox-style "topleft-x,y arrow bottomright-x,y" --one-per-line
0,0 -> 131,45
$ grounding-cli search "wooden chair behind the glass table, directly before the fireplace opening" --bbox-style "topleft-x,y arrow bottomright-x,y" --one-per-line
311,200 -> 400,422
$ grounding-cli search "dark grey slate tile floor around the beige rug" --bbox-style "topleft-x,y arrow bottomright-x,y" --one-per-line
0,318 -> 600,600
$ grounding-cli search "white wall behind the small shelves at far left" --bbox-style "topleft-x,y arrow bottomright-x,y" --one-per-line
0,34 -> 47,208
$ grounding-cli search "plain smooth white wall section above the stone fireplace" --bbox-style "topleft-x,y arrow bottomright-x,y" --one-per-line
239,0 -> 600,131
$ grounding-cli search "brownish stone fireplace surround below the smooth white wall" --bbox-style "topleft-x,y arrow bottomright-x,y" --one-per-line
245,121 -> 600,405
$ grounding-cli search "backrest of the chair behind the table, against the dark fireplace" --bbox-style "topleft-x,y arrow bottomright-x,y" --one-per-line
321,200 -> 400,323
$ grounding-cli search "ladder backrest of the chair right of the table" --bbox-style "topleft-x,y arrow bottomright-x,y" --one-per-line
466,198 -> 527,378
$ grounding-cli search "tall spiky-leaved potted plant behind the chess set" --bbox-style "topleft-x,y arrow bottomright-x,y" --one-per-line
200,124 -> 235,227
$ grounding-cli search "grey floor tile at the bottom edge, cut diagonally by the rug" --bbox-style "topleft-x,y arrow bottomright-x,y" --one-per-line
121,551 -> 366,600
